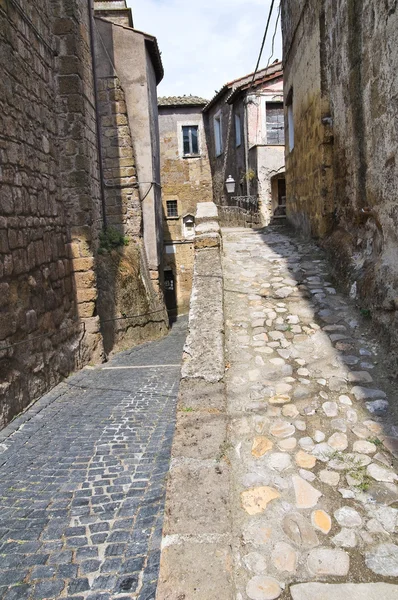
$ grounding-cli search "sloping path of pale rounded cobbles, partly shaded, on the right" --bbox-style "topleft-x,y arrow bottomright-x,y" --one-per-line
223,227 -> 398,600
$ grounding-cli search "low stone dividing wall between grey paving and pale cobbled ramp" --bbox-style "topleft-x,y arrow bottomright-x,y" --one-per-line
157,202 -> 233,600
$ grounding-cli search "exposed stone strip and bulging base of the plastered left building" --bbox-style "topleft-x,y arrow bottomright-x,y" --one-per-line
97,75 -> 167,354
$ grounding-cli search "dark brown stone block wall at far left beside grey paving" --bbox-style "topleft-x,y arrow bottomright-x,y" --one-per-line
0,0 -> 98,426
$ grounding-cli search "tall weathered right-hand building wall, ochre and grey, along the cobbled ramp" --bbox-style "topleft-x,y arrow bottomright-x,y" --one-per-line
282,0 -> 398,364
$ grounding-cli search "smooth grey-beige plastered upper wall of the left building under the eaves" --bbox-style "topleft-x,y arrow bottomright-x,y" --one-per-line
95,13 -> 163,296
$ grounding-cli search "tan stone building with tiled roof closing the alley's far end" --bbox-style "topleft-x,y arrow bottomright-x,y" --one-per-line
159,96 -> 213,314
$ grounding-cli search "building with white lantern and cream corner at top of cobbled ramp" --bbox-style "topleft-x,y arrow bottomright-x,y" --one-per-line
204,62 -> 285,224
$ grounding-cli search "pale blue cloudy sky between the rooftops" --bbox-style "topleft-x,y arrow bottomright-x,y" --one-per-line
127,0 -> 282,99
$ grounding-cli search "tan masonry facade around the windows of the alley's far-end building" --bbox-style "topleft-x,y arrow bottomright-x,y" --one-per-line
159,106 -> 213,313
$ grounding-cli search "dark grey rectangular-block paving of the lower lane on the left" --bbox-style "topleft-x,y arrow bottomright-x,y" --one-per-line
0,319 -> 186,600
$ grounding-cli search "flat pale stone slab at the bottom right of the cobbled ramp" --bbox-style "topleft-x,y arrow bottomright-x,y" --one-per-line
290,583 -> 398,600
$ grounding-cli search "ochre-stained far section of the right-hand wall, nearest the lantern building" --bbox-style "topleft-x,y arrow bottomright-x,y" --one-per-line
282,0 -> 333,237
